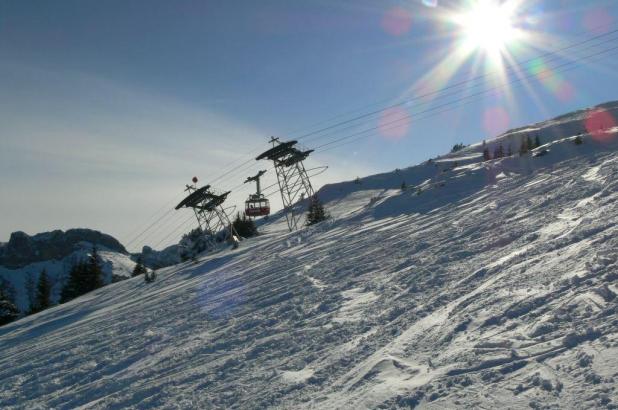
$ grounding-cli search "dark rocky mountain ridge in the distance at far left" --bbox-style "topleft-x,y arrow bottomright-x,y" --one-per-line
0,229 -> 128,269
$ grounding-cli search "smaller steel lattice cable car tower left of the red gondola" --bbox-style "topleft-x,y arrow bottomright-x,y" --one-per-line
175,177 -> 238,249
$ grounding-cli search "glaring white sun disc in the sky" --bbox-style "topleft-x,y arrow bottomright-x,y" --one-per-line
456,0 -> 517,57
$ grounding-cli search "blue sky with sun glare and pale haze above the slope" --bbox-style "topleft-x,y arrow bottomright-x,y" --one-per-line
0,0 -> 618,250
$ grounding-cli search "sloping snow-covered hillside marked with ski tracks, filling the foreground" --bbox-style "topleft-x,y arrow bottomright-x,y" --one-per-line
0,102 -> 618,409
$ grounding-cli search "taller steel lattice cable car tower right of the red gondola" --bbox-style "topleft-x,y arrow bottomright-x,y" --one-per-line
255,137 -> 315,232
